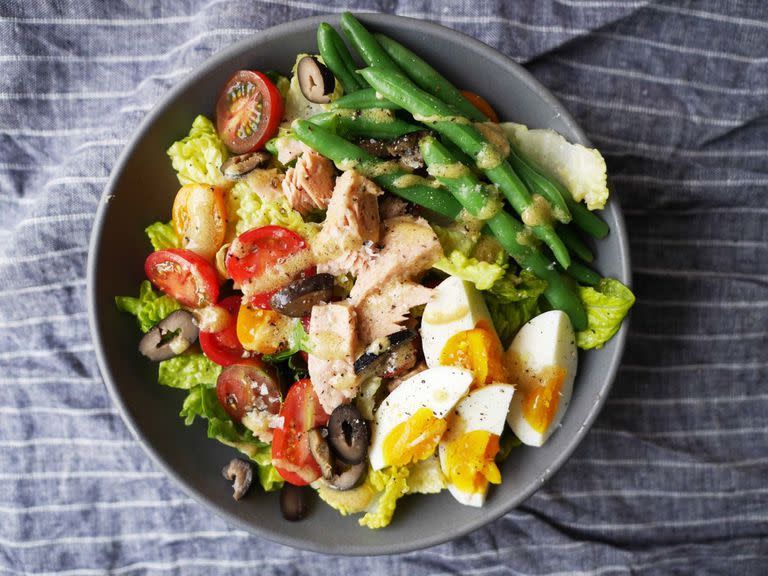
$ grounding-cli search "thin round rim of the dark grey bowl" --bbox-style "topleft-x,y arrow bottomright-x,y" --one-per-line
86,12 -> 631,556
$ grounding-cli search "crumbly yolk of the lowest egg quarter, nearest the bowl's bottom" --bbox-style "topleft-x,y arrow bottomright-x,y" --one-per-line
445,430 -> 501,494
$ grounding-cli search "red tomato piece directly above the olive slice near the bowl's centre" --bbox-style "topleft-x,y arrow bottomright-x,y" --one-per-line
225,226 -> 307,284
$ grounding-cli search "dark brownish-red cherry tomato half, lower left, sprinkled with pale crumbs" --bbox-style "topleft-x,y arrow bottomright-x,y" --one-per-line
216,360 -> 280,422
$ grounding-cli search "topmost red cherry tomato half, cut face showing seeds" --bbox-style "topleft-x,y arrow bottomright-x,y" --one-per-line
216,70 -> 283,154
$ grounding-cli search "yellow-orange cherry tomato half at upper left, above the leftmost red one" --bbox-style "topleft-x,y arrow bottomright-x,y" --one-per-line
173,184 -> 227,260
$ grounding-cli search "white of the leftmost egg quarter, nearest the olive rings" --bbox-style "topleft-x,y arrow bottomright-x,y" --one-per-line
368,366 -> 473,470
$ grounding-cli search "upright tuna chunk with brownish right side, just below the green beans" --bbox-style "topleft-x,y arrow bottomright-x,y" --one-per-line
312,170 -> 382,266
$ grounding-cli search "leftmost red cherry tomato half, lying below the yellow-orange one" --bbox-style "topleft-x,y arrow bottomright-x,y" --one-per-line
144,248 -> 219,308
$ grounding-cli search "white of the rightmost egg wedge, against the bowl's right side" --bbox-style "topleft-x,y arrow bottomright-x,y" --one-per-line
507,310 -> 578,446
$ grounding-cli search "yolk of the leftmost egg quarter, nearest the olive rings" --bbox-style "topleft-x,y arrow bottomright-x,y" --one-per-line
382,408 -> 448,466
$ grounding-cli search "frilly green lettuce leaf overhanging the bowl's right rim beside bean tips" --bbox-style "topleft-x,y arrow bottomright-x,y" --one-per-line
576,278 -> 635,350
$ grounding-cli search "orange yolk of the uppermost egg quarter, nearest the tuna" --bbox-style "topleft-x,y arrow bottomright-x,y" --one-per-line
440,323 -> 508,389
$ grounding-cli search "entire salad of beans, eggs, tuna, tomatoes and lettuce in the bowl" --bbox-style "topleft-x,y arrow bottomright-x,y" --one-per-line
116,13 -> 634,528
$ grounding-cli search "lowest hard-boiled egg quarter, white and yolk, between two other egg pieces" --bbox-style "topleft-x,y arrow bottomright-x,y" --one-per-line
438,384 -> 515,507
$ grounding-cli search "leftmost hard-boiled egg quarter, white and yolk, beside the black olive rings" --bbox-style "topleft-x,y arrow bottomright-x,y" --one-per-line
369,366 -> 472,470
